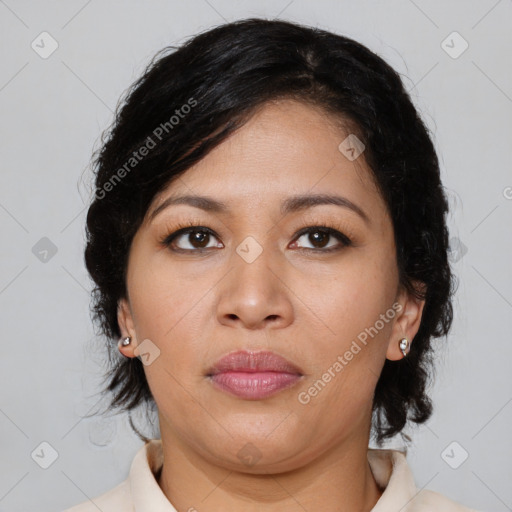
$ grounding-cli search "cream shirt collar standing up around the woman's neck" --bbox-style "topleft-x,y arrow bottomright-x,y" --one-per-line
128,439 -> 417,512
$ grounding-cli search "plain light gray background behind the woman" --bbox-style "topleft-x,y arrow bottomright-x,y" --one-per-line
0,0 -> 512,512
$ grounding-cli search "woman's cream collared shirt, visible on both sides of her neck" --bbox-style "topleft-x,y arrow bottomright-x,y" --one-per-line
63,439 -> 476,512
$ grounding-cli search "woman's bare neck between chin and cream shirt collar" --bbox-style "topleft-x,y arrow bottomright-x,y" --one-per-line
158,431 -> 382,512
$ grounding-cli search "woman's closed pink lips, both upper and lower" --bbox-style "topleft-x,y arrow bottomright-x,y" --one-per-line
207,350 -> 303,400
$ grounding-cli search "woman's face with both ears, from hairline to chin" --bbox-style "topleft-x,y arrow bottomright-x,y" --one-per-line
119,100 -> 423,472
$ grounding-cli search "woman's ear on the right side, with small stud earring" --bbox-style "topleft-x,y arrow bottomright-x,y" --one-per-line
386,281 -> 425,361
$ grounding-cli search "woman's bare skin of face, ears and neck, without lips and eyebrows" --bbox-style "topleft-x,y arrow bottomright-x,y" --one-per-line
118,100 -> 424,512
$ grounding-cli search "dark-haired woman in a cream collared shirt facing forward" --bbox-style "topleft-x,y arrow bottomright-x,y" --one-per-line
63,19 -> 476,512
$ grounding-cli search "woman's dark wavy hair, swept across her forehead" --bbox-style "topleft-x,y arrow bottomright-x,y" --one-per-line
85,18 -> 455,445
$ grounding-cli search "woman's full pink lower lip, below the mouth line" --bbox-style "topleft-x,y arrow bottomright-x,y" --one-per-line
210,372 -> 301,400
